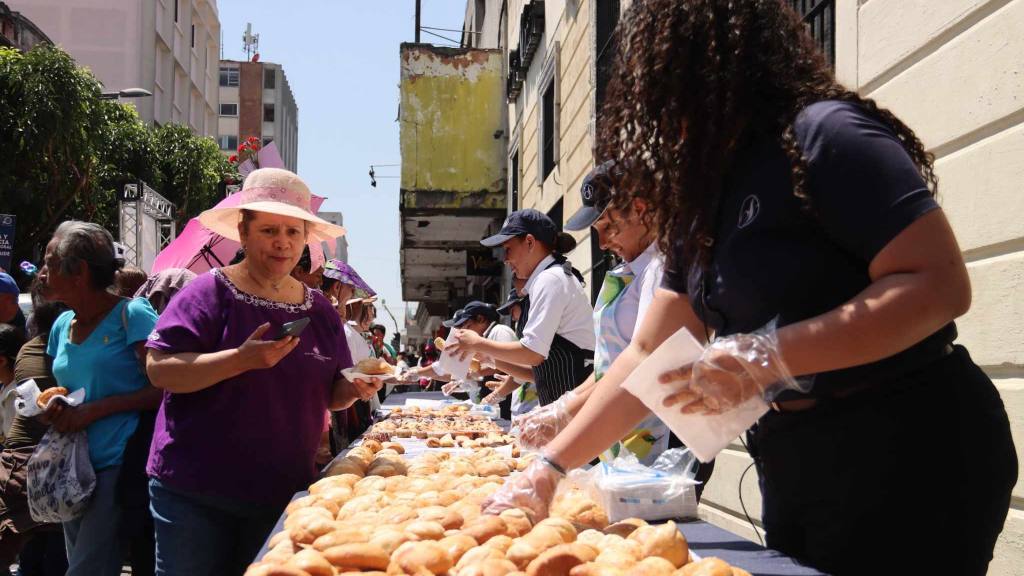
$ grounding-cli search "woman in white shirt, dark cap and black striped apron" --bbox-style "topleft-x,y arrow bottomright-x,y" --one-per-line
451,209 -> 594,405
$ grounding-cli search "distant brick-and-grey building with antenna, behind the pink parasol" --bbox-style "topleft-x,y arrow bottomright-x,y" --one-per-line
217,60 -> 299,172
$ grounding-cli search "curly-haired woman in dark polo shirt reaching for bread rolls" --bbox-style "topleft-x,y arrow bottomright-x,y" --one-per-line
488,0 -> 1017,574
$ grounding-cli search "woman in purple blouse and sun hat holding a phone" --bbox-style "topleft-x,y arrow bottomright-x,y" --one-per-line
147,168 -> 380,576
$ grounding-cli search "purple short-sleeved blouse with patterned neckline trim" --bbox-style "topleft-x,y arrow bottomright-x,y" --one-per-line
146,269 -> 352,505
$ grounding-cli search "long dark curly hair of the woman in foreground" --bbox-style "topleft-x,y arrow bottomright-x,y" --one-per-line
597,0 -> 938,266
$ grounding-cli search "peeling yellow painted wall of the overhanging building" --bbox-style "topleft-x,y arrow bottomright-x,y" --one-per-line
399,44 -> 505,208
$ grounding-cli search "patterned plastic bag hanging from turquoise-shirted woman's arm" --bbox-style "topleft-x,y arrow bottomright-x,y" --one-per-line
26,428 -> 96,523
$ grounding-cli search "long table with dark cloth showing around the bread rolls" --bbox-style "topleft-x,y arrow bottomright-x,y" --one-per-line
257,392 -> 824,576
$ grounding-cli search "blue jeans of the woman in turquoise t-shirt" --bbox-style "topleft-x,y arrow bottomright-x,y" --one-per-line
63,466 -> 122,576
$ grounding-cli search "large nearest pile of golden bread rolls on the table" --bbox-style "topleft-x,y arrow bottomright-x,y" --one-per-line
246,441 -> 746,576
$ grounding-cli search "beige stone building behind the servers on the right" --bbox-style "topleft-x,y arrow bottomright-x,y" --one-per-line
463,0 -> 1024,576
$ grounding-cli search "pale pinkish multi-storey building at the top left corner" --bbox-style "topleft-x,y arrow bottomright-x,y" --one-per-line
7,0 -> 220,136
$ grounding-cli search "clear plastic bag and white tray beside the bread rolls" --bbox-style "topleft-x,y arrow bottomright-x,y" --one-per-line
569,448 -> 699,522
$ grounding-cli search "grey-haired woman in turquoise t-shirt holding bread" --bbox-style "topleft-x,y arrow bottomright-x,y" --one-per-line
39,221 -> 160,575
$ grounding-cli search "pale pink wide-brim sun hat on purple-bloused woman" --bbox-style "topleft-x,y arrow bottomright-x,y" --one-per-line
199,168 -> 345,242
